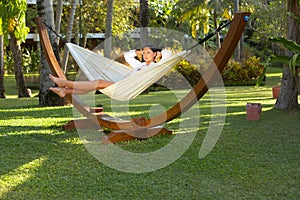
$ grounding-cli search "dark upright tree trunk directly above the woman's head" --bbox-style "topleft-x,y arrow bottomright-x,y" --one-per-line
140,0 -> 149,47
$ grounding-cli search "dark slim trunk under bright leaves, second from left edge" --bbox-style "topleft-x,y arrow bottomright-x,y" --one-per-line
9,34 -> 30,98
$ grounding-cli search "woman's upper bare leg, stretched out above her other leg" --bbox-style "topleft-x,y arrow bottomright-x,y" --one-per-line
49,74 -> 114,91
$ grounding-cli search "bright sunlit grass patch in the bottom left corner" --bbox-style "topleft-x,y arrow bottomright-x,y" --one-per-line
0,156 -> 47,198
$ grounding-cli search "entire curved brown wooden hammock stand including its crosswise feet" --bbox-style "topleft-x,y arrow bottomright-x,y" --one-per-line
36,12 -> 250,144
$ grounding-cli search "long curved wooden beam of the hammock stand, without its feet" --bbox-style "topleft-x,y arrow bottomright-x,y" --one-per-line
36,12 -> 250,138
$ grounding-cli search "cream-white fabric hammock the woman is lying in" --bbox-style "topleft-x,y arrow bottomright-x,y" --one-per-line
67,43 -> 189,101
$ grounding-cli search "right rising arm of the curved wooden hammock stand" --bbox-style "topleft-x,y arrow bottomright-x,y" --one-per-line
146,12 -> 250,126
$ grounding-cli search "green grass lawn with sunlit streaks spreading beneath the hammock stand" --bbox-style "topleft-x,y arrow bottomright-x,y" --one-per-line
0,69 -> 300,200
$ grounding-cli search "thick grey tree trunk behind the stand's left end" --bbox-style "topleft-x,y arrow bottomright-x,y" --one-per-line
37,0 -> 66,106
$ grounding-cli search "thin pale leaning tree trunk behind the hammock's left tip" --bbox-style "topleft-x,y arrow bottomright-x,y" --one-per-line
62,0 -> 77,74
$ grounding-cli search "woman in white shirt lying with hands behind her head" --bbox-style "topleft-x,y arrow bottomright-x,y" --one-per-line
49,45 -> 172,97
